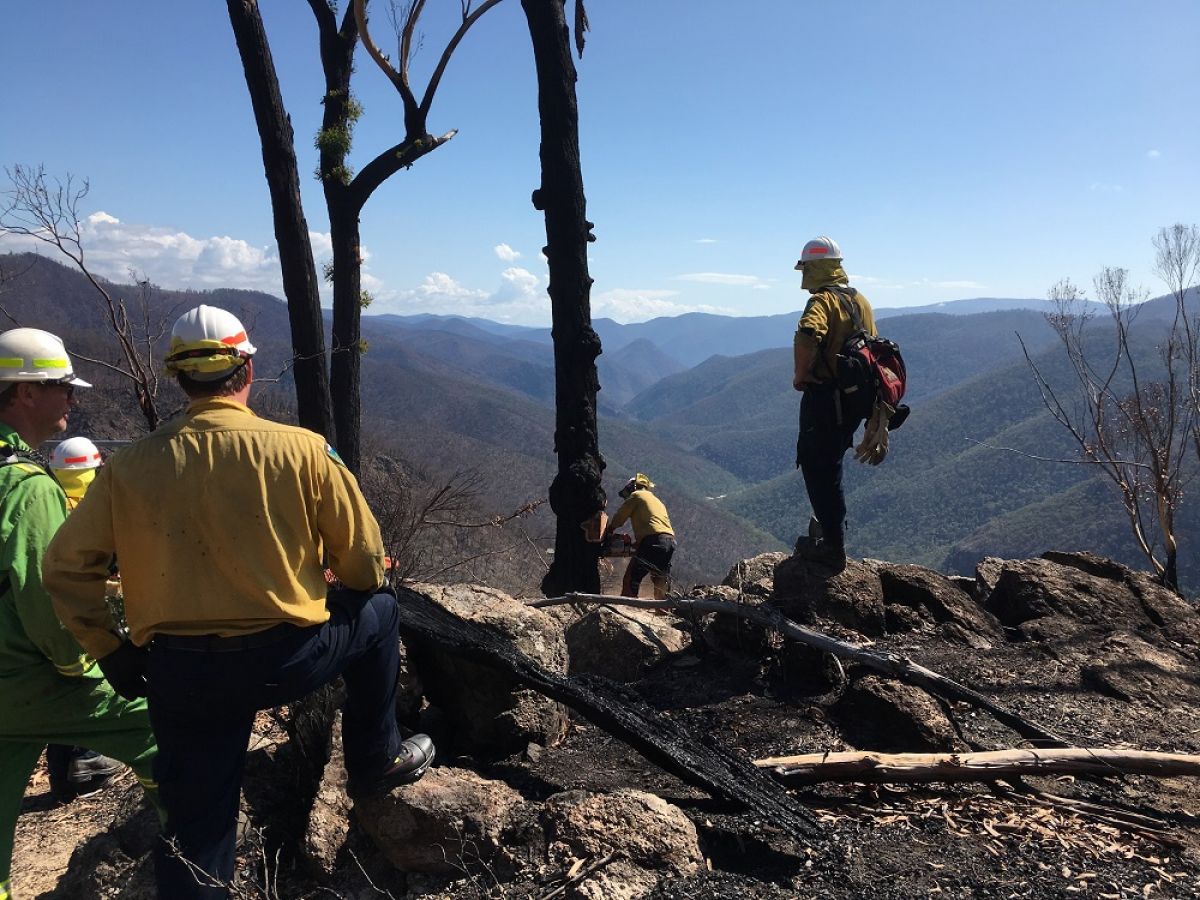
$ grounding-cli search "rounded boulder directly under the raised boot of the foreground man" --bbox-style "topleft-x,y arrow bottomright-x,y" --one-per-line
355,767 -> 526,874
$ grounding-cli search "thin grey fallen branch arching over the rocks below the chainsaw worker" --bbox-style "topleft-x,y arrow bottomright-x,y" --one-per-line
530,594 -> 1070,748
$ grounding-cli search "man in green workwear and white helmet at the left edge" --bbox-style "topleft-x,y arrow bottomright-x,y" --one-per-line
0,328 -> 156,900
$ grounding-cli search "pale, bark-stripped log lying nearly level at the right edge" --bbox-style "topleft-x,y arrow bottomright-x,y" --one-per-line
754,748 -> 1200,786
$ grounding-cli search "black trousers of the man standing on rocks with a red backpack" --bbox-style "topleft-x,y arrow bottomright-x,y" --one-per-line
796,383 -> 863,546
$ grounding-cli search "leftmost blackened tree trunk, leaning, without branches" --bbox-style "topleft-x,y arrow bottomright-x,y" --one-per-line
227,0 -> 334,440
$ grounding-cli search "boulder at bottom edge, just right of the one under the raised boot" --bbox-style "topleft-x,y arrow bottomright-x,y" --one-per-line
541,790 -> 704,900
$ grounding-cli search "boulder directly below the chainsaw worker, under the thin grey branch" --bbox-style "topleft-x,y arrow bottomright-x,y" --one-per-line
566,606 -> 691,682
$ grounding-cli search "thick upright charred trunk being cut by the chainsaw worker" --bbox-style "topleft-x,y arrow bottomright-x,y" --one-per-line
521,0 -> 605,595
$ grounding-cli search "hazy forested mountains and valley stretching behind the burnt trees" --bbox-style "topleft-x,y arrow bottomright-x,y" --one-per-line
0,257 -> 1200,592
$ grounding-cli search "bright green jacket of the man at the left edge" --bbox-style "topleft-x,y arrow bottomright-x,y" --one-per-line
0,422 -> 94,681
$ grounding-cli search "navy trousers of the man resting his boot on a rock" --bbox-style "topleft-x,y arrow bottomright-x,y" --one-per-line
149,592 -> 401,900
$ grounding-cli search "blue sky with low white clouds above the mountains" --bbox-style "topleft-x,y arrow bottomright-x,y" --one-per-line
0,0 -> 1200,324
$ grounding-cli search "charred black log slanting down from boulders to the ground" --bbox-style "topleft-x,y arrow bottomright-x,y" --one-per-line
388,588 -> 820,838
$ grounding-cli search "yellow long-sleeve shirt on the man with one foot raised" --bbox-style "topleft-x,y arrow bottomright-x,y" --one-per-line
44,398 -> 384,659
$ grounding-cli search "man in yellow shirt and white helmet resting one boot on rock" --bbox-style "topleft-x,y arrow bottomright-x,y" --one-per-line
44,306 -> 434,900
